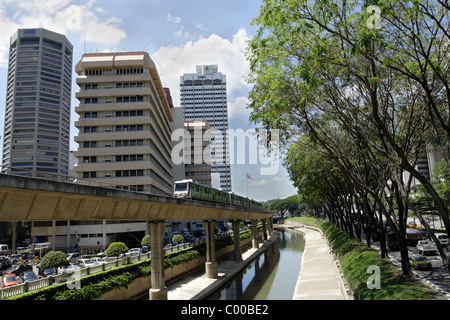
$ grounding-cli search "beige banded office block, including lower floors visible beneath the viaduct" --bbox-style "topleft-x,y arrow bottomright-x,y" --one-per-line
33,52 -> 176,253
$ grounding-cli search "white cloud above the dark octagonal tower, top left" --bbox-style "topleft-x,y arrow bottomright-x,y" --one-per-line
0,0 -> 126,65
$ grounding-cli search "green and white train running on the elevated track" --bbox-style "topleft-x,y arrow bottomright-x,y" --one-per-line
173,179 -> 262,209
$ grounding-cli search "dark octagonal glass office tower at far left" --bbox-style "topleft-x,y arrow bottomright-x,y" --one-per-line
2,28 -> 73,176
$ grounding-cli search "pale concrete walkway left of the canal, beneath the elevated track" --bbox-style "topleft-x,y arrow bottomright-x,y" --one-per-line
167,231 -> 278,300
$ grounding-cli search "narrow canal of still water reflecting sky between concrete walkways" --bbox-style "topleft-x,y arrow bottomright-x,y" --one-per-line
208,229 -> 305,300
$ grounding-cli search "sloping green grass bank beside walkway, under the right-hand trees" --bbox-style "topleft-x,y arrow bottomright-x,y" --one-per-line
289,217 -> 436,300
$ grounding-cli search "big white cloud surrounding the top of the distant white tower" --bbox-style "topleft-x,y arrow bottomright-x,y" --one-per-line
151,29 -> 250,117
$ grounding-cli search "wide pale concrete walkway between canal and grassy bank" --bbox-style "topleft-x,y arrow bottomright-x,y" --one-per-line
289,225 -> 352,300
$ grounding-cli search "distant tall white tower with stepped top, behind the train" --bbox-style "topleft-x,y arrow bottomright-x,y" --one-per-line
180,65 -> 231,191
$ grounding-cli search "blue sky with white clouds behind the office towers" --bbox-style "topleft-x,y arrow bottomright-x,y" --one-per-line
0,0 -> 296,201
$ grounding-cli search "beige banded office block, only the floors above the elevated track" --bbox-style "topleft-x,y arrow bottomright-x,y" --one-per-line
74,52 -> 173,195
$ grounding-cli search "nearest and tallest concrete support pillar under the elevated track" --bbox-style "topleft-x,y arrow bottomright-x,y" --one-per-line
147,220 -> 167,300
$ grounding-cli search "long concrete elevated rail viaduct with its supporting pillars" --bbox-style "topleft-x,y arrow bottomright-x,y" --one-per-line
0,174 -> 273,300
